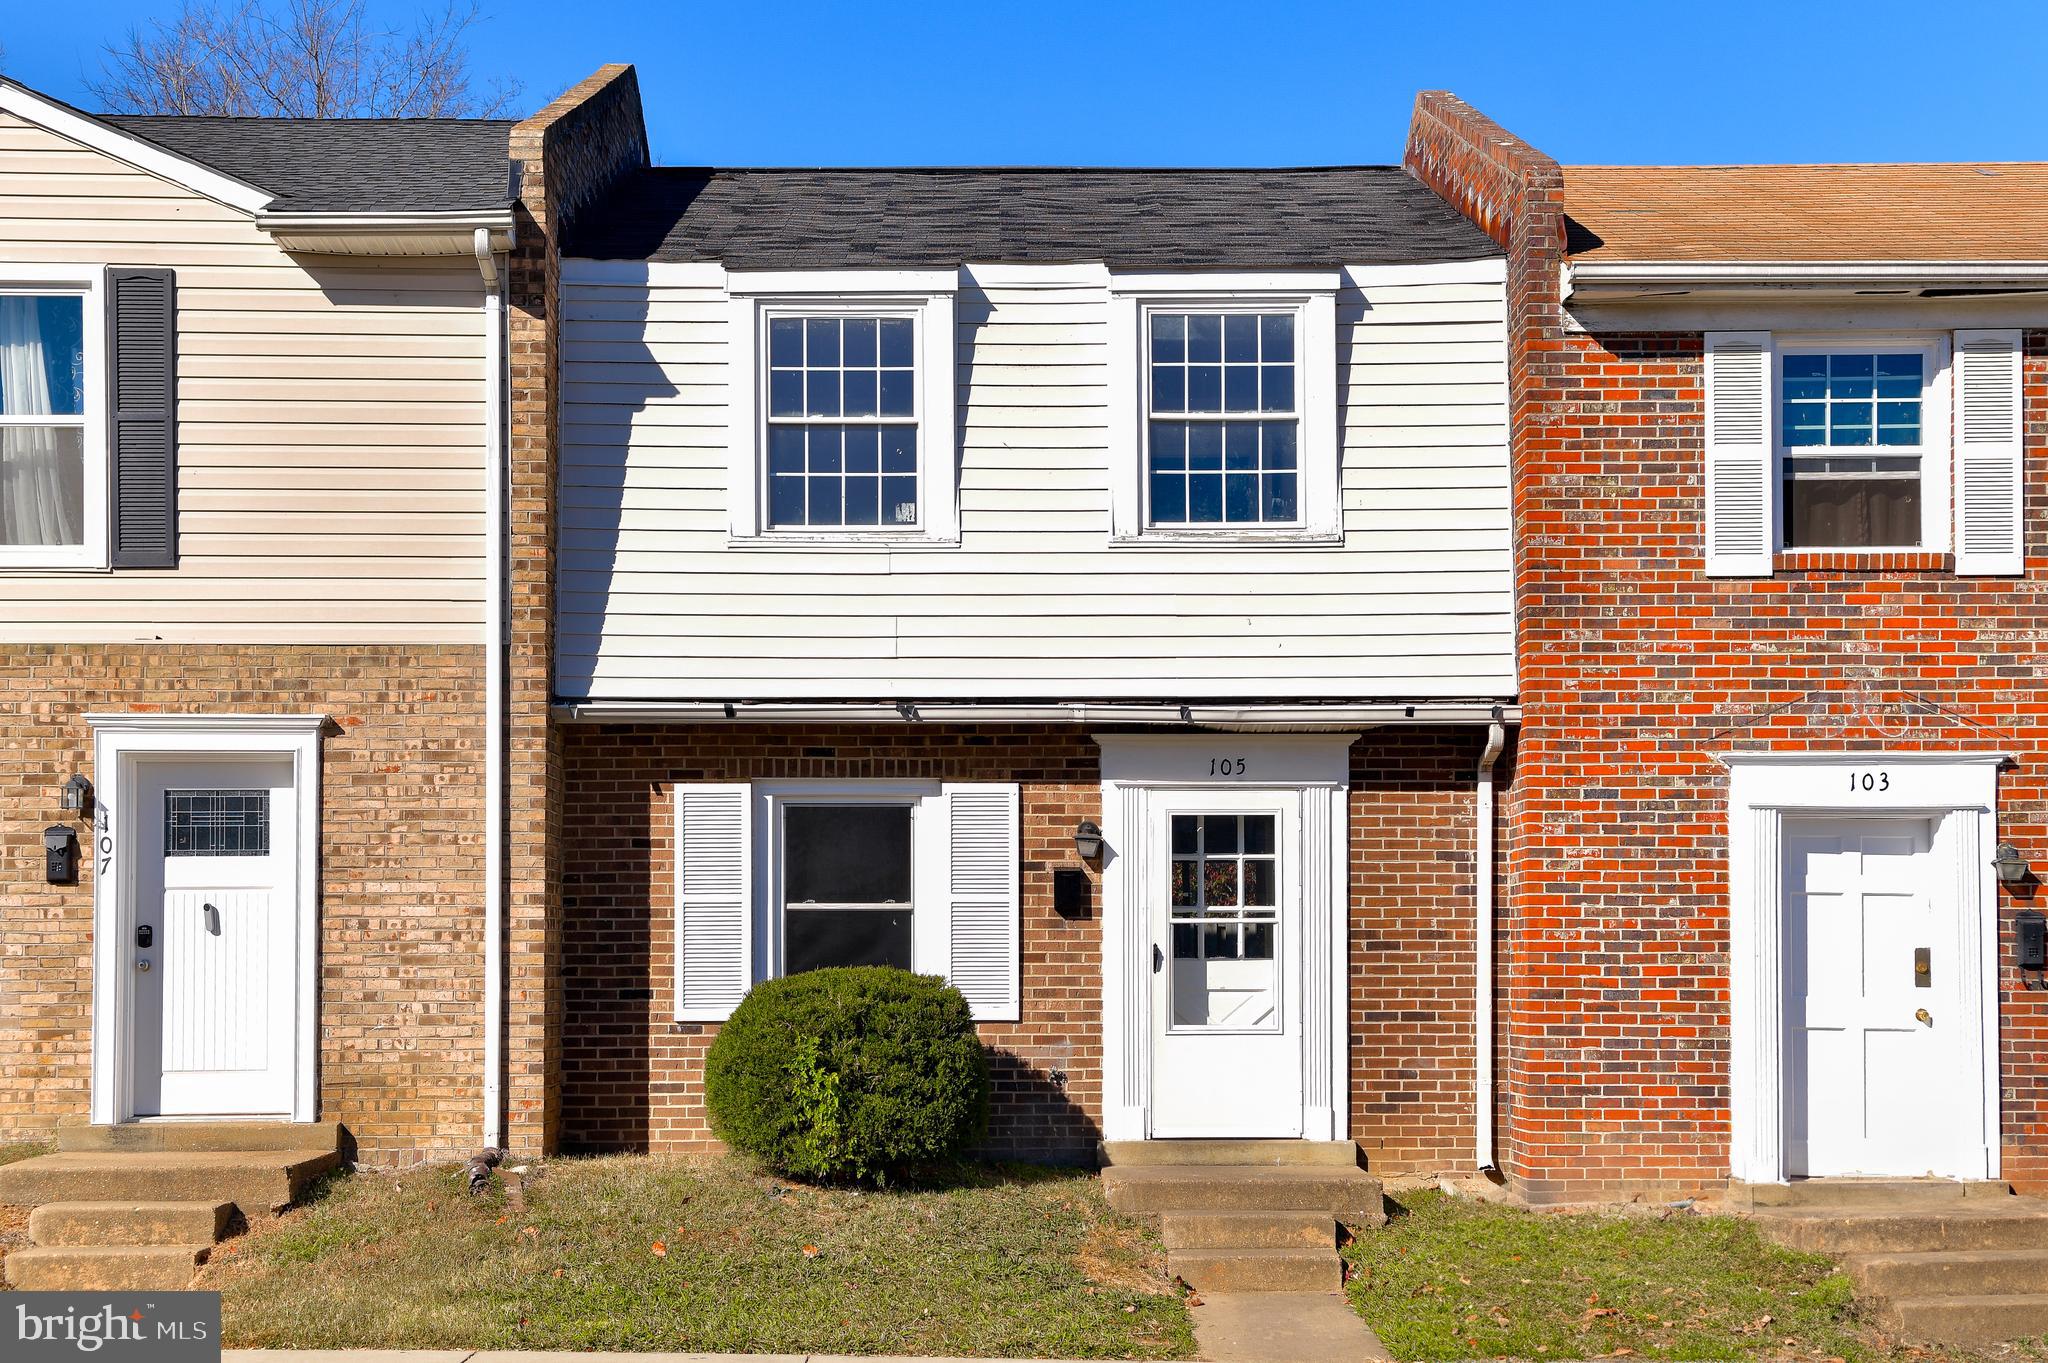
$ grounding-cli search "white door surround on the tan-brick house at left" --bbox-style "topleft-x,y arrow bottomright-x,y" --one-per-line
86,714 -> 328,1126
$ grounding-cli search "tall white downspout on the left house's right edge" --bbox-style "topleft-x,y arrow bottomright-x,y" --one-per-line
475,227 -> 510,1148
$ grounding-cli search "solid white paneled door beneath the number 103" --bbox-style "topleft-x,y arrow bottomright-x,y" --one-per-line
1784,819 -> 1982,1177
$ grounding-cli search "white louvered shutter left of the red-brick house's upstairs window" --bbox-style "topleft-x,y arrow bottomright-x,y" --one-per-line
1706,332 -> 1778,577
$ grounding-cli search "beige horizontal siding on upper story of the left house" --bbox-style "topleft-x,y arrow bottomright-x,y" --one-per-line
0,115 -> 485,643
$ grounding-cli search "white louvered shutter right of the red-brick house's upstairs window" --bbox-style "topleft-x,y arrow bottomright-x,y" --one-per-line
1956,332 -> 2028,577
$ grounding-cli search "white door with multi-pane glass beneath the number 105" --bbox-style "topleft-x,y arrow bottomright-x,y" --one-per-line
1141,790 -> 1303,1138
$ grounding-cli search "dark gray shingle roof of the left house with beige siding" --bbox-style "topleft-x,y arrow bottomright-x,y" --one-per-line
104,115 -> 512,213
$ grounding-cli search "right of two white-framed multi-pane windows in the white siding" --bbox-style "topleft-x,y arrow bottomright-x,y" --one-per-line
1110,270 -> 1343,544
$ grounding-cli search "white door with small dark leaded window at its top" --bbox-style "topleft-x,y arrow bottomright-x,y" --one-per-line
127,759 -> 299,1117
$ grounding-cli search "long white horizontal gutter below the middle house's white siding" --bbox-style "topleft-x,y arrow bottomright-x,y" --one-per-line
555,700 -> 1522,729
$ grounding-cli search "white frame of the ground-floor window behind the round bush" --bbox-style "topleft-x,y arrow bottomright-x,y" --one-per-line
750,780 -> 950,984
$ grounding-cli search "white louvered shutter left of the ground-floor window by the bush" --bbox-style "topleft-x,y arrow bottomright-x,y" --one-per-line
676,782 -> 754,1021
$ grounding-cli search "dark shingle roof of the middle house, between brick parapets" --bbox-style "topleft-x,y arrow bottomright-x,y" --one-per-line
565,166 -> 1499,270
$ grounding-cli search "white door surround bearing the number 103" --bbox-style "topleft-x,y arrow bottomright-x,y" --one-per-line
1718,753 -> 2007,1183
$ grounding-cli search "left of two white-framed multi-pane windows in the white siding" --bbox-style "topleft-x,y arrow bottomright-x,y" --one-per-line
727,270 -> 958,544
